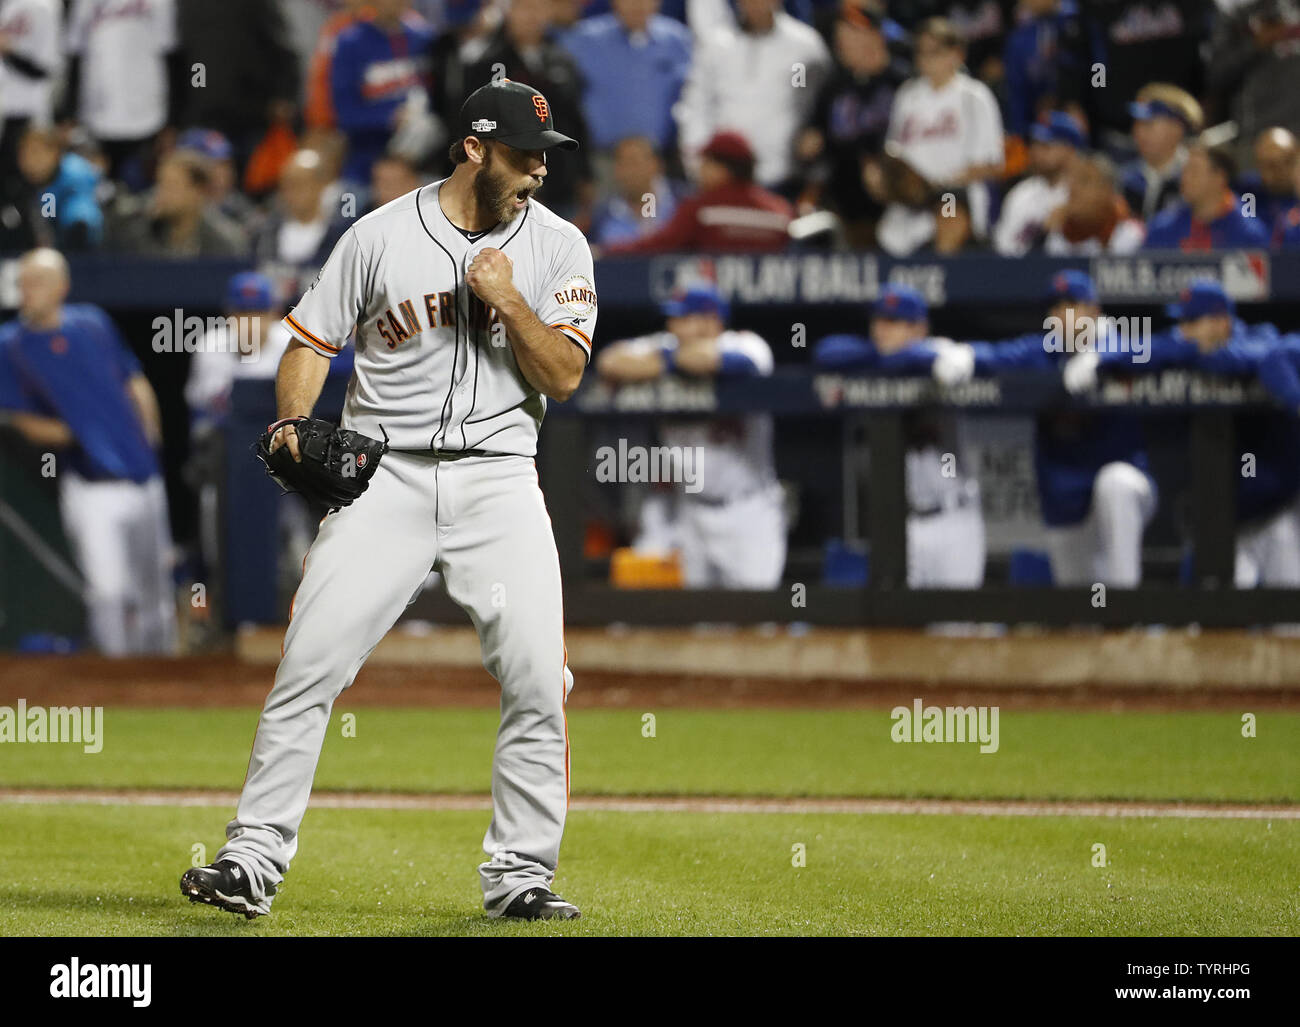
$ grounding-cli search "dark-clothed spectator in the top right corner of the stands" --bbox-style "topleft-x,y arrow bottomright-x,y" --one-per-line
1205,0 -> 1300,163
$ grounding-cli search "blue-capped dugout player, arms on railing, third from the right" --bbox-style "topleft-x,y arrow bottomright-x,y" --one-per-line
813,285 -> 984,589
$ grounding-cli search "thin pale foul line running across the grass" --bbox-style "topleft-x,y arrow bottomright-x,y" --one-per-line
0,788 -> 1300,820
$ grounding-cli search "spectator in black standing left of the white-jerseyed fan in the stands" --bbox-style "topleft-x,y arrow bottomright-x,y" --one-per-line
796,0 -> 907,246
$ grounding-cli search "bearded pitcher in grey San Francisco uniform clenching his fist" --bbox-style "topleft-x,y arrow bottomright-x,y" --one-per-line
181,79 -> 597,919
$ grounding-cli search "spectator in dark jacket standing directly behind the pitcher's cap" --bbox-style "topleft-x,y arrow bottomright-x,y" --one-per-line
438,0 -> 595,222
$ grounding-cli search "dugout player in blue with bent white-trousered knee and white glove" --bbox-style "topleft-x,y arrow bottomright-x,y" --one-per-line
935,270 -> 1156,589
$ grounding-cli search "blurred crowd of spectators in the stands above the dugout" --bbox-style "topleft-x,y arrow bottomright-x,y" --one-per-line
0,0 -> 1300,289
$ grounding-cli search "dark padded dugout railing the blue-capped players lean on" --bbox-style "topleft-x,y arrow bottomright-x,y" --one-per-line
222,368 -> 1300,627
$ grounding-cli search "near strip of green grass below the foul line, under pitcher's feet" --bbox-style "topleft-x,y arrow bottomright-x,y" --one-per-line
0,806 -> 1300,936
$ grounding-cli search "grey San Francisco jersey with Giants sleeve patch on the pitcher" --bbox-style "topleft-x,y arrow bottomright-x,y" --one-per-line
285,182 -> 597,456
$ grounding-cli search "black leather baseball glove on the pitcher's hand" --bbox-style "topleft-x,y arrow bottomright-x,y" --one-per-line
254,417 -> 389,510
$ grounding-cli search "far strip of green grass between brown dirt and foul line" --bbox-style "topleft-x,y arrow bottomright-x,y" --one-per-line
0,709 -> 1300,802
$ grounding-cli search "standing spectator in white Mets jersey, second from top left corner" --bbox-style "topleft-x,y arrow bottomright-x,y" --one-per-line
65,0 -> 189,191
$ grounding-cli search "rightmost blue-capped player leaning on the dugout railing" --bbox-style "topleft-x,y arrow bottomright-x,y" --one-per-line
1065,280 -> 1300,589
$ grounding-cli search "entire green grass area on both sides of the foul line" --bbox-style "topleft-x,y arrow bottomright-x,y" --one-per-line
0,707 -> 1300,936
